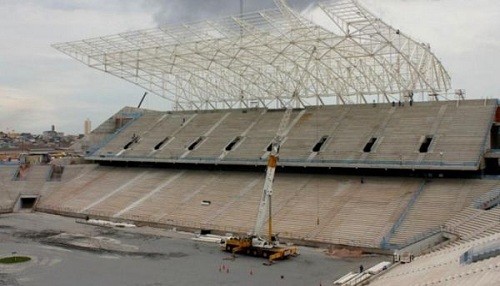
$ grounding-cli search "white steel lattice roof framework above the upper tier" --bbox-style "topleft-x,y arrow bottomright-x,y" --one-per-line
54,0 -> 450,110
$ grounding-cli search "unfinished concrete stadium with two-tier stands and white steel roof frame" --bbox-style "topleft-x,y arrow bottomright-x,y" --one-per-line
0,0 -> 500,285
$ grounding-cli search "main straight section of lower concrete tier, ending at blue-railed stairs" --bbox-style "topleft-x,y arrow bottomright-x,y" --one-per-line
39,165 -> 446,247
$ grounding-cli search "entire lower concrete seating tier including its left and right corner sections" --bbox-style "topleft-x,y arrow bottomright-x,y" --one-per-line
0,162 -> 492,251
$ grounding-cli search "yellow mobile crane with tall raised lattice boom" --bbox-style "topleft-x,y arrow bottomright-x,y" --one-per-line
222,41 -> 316,263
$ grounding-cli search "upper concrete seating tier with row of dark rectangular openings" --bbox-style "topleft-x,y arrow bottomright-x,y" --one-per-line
88,100 -> 496,170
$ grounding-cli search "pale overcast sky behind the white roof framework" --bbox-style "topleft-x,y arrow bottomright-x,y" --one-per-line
0,0 -> 500,134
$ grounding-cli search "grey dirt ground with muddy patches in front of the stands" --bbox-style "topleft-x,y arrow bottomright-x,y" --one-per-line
0,213 -> 388,286
